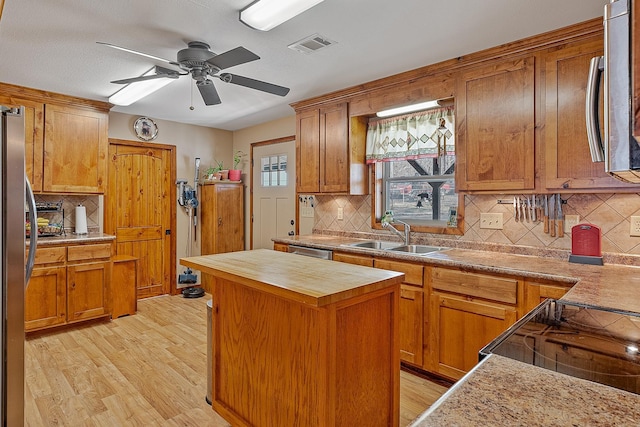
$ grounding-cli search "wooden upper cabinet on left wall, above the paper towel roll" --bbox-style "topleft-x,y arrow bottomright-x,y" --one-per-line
0,83 -> 110,194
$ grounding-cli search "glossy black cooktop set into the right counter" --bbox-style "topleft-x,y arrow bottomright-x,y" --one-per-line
480,300 -> 640,394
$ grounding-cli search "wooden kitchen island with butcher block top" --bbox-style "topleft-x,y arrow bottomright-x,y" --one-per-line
180,249 -> 404,426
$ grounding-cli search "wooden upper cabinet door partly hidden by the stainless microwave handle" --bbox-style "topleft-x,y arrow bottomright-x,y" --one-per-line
544,37 -> 637,191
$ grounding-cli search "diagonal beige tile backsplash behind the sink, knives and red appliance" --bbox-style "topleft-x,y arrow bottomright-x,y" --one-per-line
314,193 -> 640,257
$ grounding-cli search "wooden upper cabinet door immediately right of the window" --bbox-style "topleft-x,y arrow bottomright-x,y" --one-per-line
456,57 -> 535,191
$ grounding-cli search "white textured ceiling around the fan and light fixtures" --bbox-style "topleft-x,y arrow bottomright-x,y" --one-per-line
0,0 -> 606,130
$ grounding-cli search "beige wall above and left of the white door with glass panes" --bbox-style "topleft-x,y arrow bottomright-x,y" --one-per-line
233,113 -> 296,249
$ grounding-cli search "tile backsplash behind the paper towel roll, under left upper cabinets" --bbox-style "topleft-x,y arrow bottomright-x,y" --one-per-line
34,194 -> 102,233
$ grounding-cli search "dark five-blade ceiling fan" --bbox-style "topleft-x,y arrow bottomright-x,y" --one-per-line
97,41 -> 289,105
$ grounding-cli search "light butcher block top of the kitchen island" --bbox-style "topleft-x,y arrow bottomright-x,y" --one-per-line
180,249 -> 404,307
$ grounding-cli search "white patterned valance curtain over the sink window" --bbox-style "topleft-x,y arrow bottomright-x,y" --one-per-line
366,107 -> 455,163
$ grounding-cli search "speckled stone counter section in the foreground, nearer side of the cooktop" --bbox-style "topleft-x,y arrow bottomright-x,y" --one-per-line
410,354 -> 640,427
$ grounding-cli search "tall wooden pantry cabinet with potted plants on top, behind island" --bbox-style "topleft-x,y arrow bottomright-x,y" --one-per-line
198,181 -> 244,292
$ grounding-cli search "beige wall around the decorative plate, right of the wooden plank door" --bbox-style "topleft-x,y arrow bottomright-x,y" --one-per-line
109,111 -> 233,279
